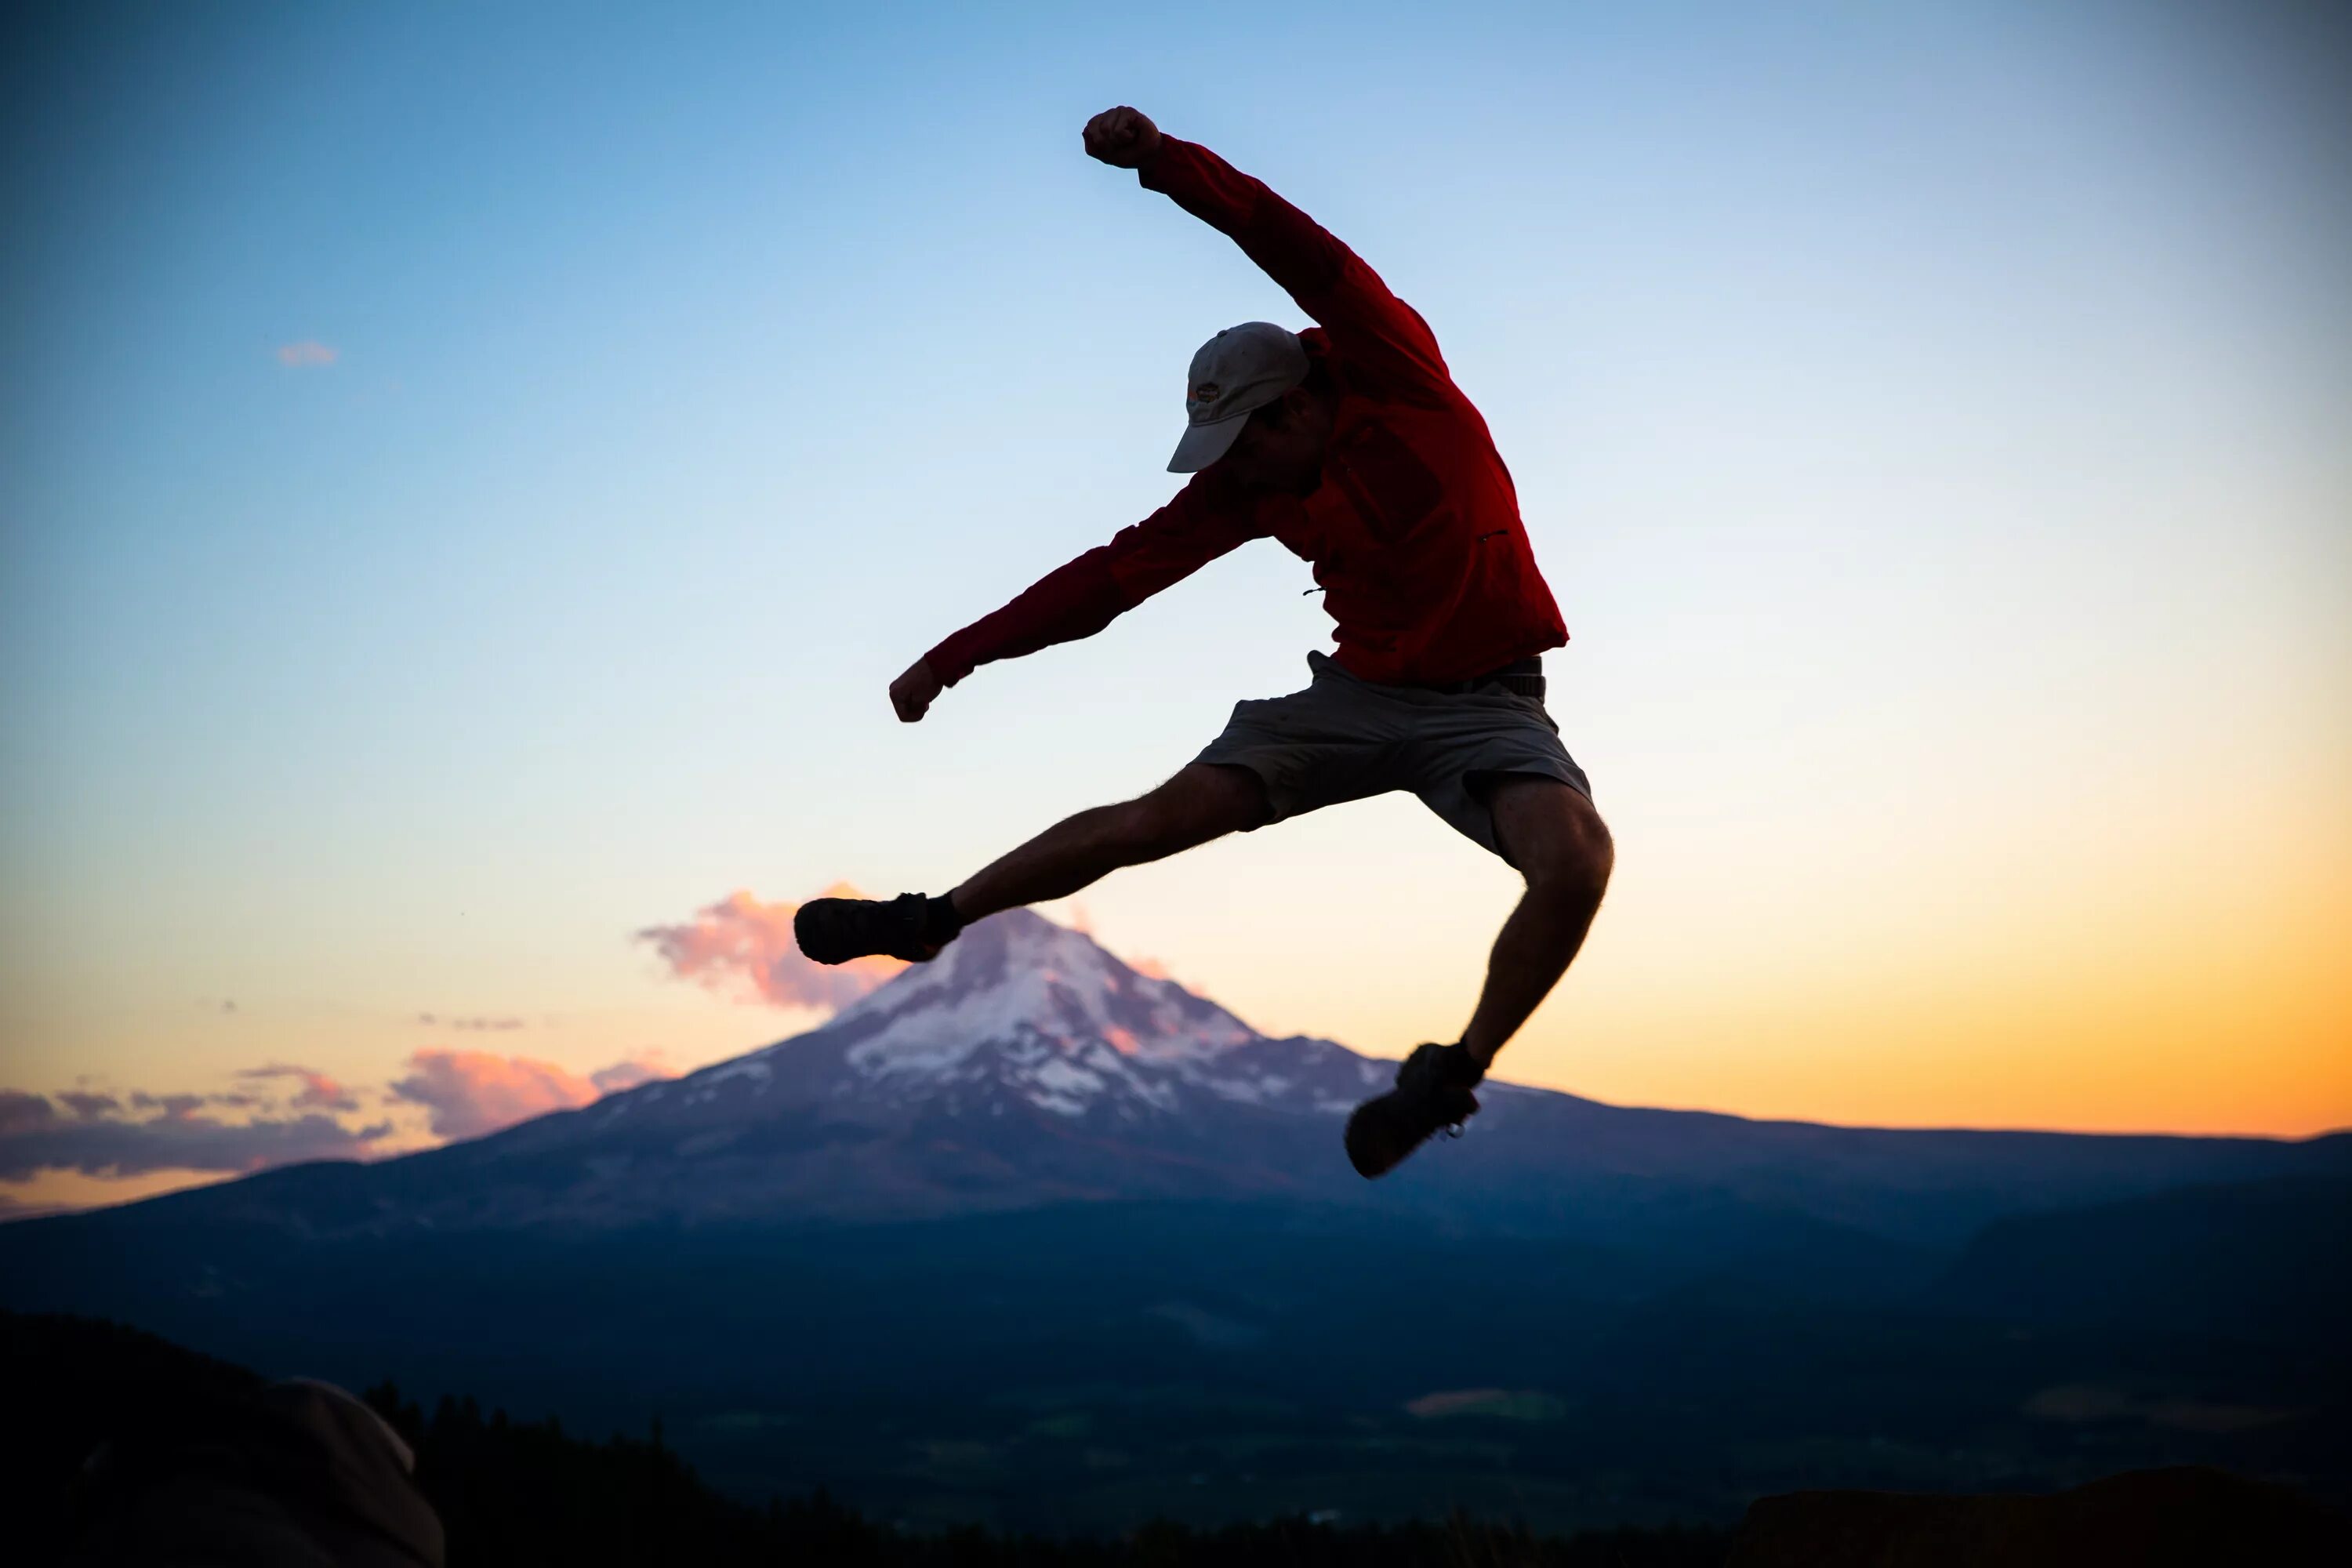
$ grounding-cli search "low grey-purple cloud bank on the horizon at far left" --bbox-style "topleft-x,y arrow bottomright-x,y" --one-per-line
0,1088 -> 393,1180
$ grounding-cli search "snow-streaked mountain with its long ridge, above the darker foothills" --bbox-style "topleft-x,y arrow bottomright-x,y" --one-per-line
7,909 -> 2352,1253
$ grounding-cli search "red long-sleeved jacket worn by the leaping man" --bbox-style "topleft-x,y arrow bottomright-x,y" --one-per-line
927,136 -> 1569,687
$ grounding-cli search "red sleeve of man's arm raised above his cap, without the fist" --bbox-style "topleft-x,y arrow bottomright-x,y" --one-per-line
1136,132 -> 1449,381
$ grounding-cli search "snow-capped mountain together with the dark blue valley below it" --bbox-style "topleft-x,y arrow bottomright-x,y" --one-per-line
0,912 -> 2352,1530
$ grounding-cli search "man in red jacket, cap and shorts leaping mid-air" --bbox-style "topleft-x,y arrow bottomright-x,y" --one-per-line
793,108 -> 1613,1175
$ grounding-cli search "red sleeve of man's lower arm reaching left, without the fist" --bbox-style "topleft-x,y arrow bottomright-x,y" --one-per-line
924,475 -> 1256,687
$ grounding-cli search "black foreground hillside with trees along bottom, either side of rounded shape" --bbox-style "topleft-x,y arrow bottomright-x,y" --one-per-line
0,1314 -> 1729,1568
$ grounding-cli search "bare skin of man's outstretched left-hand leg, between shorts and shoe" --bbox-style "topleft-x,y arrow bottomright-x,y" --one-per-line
948,762 -> 1268,921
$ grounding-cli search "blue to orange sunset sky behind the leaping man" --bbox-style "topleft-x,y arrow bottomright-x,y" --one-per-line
0,2 -> 2352,1213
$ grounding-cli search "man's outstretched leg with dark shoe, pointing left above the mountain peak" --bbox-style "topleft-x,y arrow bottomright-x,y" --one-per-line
793,762 -> 1270,964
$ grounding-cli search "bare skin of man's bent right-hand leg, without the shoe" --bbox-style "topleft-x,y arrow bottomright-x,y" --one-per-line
1463,774 -> 1616,1072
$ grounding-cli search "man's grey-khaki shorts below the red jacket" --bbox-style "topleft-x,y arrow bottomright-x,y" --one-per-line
1195,654 -> 1592,860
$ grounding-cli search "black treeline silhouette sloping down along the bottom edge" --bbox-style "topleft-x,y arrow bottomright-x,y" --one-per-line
367,1385 -> 1729,1568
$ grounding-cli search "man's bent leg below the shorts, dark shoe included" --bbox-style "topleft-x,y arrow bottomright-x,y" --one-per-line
1345,774 -> 1616,1175
